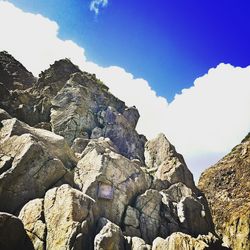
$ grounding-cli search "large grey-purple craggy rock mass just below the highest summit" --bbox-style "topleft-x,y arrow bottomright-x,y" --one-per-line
51,69 -> 145,161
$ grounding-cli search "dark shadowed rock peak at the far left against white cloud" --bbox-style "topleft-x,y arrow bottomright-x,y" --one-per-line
0,51 -> 36,90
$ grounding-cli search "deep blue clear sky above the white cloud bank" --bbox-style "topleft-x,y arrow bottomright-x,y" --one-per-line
10,0 -> 250,101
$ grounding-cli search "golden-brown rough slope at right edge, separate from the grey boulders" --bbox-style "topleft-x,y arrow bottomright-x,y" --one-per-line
199,134 -> 250,249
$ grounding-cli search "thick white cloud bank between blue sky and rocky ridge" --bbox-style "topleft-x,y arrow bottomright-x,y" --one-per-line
0,1 -> 250,181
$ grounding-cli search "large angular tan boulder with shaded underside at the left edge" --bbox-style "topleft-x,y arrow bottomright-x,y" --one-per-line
0,119 -> 74,212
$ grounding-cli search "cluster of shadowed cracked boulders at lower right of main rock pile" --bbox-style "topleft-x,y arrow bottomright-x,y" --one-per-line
123,183 -> 214,244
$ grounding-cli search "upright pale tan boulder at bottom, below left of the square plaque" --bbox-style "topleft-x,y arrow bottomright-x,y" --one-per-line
44,184 -> 94,250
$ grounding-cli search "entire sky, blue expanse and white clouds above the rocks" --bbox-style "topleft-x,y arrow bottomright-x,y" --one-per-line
0,0 -> 250,180
